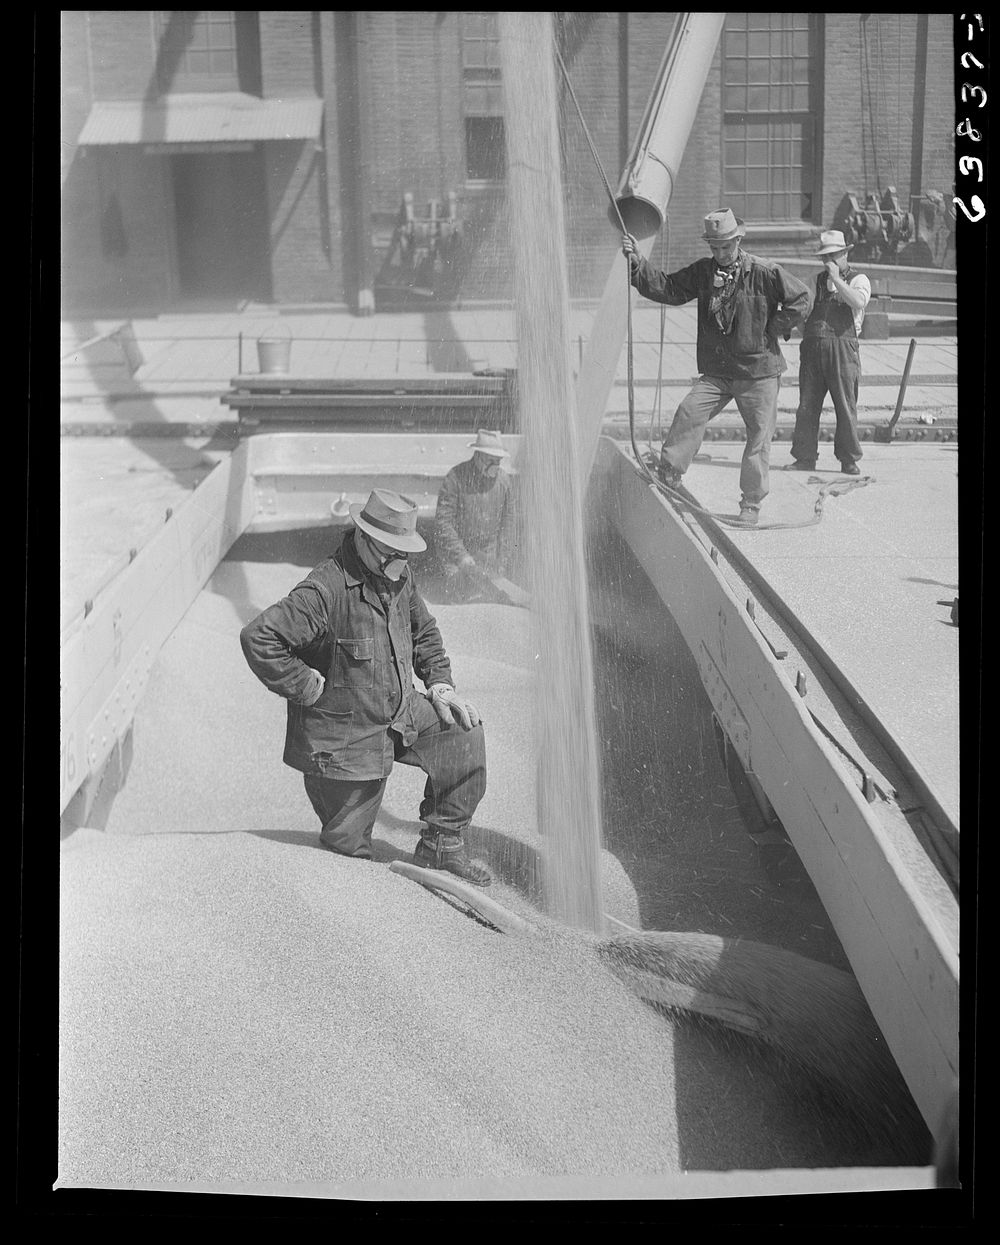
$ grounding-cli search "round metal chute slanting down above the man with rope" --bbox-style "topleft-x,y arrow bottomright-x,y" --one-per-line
615,12 -> 726,237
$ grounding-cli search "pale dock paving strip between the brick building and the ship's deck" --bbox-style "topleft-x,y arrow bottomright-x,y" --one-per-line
60,298 -> 958,439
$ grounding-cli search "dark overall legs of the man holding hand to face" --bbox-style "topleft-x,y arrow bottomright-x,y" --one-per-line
792,337 -> 862,467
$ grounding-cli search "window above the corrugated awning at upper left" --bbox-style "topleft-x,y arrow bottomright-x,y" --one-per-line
154,11 -> 260,92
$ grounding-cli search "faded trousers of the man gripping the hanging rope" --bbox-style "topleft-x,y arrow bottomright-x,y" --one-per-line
660,376 -> 781,509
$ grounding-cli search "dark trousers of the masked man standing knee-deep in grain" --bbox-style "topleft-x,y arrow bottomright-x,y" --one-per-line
304,697 -> 486,859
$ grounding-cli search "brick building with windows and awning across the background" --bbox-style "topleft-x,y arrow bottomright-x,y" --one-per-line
61,10 -> 955,312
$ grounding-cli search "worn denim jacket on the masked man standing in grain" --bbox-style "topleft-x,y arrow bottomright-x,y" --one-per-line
239,532 -> 453,782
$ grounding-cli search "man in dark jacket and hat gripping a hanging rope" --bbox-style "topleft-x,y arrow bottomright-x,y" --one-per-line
621,208 -> 809,527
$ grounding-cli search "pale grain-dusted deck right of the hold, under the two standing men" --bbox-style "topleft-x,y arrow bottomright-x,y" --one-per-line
684,443 -> 960,825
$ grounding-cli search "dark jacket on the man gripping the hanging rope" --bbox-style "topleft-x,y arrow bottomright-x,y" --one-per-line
631,250 -> 812,380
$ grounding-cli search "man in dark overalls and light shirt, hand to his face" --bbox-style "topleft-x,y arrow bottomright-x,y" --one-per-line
790,229 -> 872,476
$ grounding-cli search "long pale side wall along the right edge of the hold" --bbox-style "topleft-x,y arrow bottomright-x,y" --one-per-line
601,441 -> 959,1128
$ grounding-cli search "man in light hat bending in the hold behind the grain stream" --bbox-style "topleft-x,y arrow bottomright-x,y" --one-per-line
433,428 -> 517,595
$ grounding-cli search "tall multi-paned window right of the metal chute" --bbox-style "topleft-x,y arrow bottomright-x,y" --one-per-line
722,12 -> 819,222
